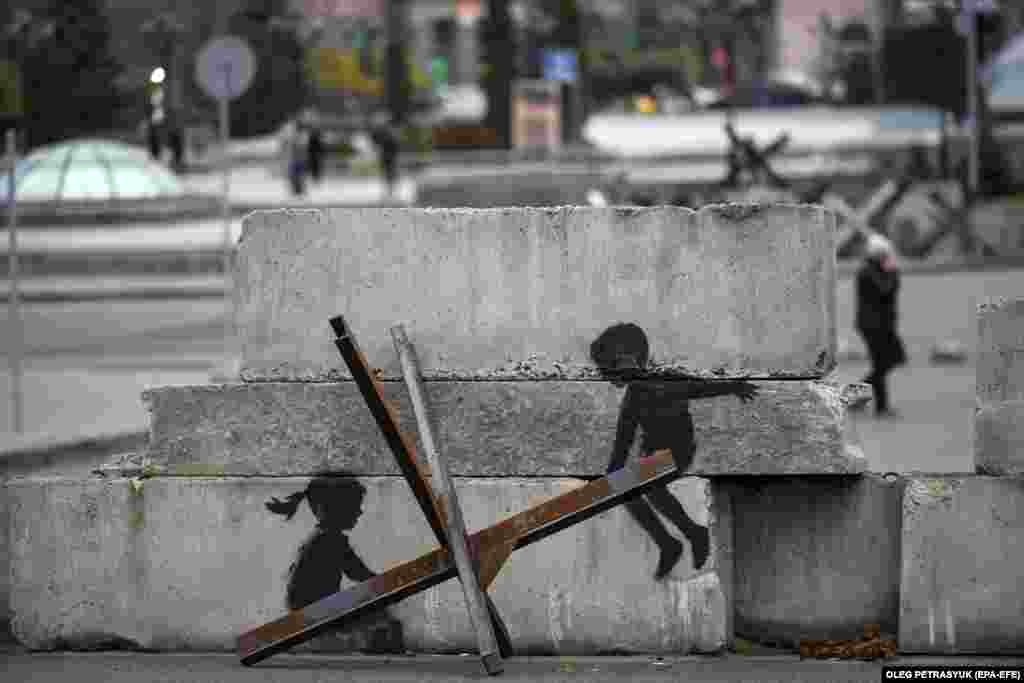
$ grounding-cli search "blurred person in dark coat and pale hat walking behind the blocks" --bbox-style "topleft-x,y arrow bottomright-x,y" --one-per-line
856,234 -> 906,417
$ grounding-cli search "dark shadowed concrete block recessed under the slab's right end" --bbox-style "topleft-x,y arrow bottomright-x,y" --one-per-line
729,474 -> 903,646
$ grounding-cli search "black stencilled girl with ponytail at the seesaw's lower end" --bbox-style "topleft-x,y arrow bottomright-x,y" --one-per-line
266,473 -> 404,652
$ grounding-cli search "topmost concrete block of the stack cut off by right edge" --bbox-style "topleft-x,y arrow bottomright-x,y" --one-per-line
976,299 -> 1024,402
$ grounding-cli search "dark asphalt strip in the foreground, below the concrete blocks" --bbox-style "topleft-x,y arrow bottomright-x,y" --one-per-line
6,652 -> 1024,683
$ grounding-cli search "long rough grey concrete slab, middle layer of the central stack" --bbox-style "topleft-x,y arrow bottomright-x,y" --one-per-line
143,382 -> 866,476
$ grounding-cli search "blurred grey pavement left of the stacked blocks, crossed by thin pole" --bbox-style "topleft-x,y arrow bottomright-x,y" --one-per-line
0,297 -> 231,453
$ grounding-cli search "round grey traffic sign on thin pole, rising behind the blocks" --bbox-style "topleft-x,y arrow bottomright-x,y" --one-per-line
196,36 -> 256,344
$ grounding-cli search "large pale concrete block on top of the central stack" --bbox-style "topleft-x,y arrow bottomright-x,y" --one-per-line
234,205 -> 836,381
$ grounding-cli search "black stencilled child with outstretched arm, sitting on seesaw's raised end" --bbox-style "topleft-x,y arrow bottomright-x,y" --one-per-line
590,323 -> 757,580
